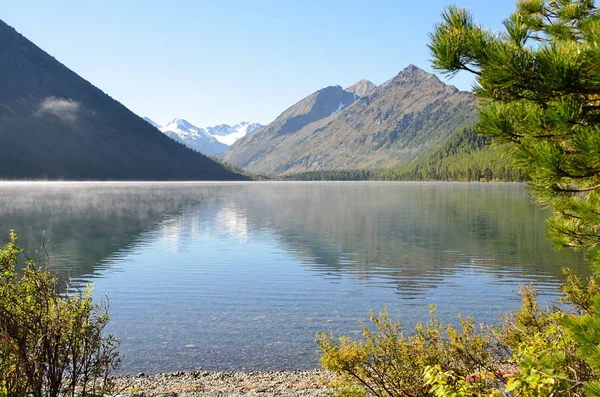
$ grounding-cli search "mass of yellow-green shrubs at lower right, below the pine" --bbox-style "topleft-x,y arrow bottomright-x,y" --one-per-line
317,280 -> 598,397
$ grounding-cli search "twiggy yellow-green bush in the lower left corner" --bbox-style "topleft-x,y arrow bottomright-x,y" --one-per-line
0,231 -> 118,397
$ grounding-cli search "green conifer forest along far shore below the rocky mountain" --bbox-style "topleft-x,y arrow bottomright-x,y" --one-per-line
282,128 -> 527,182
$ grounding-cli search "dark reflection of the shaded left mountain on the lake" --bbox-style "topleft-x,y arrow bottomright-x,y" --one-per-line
0,183 -> 217,281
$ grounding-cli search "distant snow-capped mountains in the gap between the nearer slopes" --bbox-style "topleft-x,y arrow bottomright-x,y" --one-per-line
144,117 -> 262,156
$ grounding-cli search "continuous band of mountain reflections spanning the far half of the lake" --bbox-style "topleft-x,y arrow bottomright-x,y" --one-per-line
0,183 -> 587,293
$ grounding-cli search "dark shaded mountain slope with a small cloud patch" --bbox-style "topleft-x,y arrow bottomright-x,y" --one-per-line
0,21 -> 245,180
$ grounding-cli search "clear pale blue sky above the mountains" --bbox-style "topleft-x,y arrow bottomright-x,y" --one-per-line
0,0 -> 515,126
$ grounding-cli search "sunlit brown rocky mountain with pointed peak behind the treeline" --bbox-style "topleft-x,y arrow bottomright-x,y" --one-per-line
224,65 -> 477,174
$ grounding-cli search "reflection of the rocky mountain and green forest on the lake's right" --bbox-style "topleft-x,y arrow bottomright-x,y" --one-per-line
223,183 -> 587,294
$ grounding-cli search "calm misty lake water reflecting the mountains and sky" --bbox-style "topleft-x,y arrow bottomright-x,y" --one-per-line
0,182 -> 587,373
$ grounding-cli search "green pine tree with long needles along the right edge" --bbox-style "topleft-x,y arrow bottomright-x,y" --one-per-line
430,0 -> 600,390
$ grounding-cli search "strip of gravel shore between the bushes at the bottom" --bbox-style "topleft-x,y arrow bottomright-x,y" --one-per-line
113,370 -> 333,397
